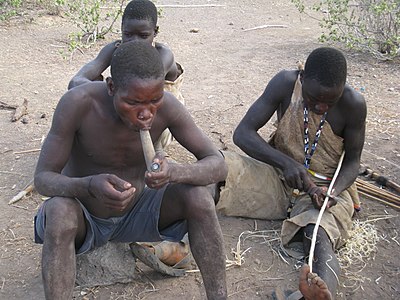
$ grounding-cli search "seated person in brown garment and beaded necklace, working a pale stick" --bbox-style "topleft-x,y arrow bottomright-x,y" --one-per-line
218,48 -> 367,300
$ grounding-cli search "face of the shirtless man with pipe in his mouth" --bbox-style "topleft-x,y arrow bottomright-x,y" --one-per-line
108,78 -> 164,131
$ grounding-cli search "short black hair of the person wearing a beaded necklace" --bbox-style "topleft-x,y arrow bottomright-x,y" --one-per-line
304,47 -> 347,87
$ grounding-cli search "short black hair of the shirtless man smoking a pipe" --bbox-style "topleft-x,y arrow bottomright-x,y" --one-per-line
111,41 -> 164,87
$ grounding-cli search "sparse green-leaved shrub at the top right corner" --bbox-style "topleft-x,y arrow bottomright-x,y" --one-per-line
291,0 -> 400,59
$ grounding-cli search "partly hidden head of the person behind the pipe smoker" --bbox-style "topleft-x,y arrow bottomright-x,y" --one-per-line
121,0 -> 158,43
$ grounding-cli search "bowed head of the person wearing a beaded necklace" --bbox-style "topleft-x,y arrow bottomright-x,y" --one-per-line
302,47 -> 347,114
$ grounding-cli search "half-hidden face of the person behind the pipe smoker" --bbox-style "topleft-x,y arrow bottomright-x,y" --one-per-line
121,19 -> 155,44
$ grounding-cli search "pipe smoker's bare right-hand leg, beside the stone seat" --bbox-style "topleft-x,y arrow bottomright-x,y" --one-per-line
159,185 -> 227,299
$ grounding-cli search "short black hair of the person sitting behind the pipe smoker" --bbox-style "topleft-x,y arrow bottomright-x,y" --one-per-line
122,0 -> 158,28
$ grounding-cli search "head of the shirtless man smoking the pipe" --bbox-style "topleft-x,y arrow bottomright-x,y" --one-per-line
107,41 -> 164,129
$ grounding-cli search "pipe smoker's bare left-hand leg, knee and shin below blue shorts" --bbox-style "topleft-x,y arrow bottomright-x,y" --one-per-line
42,197 -> 86,300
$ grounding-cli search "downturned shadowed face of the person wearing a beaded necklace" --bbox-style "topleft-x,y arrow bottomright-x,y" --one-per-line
302,78 -> 344,115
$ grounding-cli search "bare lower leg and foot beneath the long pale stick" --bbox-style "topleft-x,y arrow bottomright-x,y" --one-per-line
302,224 -> 340,300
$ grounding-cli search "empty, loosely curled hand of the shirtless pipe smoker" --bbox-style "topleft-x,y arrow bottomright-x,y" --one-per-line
88,174 -> 136,211
